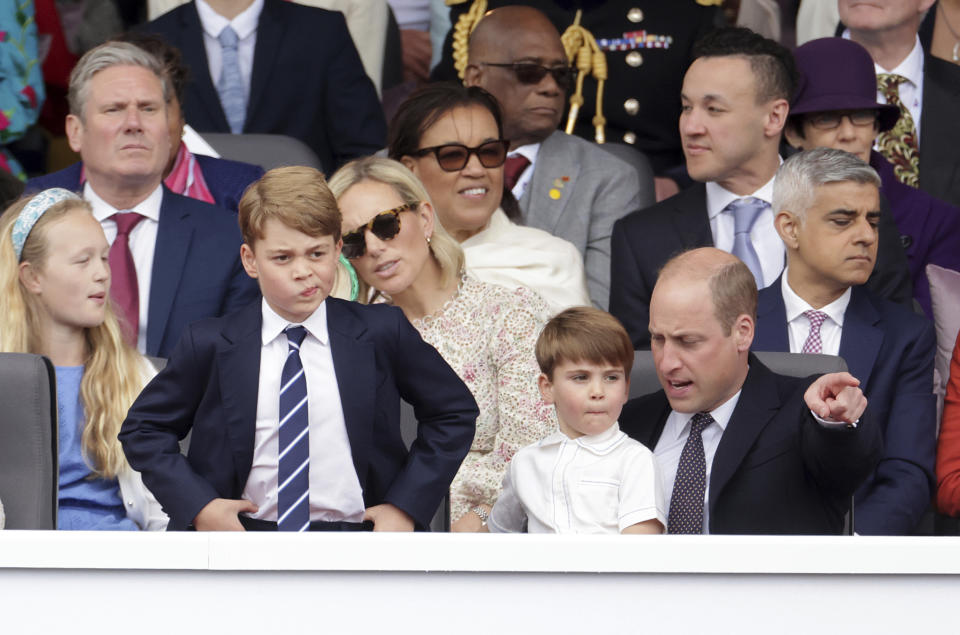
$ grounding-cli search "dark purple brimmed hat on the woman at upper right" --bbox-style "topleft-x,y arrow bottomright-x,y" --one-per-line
790,37 -> 900,132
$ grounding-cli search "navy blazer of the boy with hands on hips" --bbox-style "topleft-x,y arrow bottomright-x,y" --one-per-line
120,298 -> 478,530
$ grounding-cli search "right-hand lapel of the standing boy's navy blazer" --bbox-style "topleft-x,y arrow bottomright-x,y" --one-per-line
326,298 -> 377,486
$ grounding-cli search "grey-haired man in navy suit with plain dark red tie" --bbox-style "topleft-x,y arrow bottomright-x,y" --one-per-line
27,42 -> 257,356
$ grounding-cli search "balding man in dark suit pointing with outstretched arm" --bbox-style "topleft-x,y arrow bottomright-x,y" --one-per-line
620,248 -> 881,534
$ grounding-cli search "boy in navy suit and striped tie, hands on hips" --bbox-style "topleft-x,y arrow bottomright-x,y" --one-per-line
120,167 -> 478,531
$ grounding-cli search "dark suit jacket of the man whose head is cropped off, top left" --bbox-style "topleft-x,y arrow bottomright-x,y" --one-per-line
141,0 -> 387,175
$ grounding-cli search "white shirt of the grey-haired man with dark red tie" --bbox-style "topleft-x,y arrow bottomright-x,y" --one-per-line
83,181 -> 163,354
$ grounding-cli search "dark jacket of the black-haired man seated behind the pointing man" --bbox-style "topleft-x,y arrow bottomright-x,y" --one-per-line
610,183 -> 913,349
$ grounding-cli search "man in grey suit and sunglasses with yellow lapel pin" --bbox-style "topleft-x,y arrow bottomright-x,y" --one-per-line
464,6 -> 654,309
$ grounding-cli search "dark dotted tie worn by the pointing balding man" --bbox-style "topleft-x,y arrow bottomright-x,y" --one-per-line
667,412 -> 713,534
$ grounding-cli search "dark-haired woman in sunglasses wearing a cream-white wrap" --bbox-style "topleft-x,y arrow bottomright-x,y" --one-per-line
387,84 -> 590,311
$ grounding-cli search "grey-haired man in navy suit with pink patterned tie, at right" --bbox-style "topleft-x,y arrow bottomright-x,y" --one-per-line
754,148 -> 936,535
